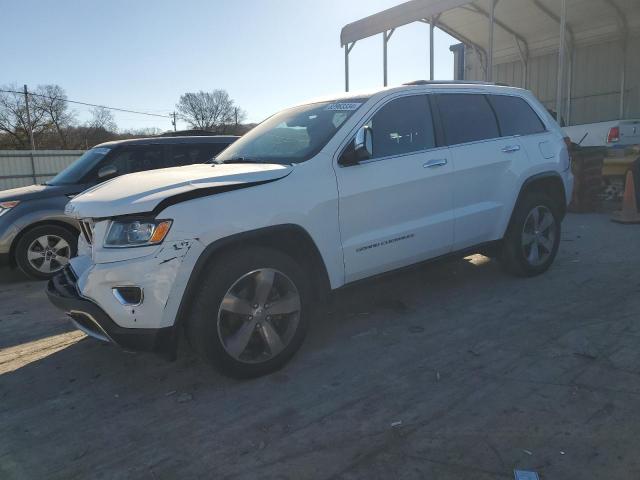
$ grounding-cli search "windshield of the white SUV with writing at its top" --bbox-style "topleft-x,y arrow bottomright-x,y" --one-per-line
216,98 -> 367,165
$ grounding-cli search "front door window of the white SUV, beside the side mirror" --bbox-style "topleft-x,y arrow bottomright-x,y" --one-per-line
367,95 -> 435,158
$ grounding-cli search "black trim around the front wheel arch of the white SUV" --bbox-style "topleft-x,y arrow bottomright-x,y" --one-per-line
175,224 -> 331,327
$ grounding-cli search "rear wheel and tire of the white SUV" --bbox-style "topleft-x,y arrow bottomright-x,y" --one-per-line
501,192 -> 561,277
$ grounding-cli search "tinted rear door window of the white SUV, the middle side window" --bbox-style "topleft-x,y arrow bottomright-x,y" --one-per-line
436,93 -> 500,145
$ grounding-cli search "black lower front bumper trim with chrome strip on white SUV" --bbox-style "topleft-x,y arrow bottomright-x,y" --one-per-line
47,267 -> 176,357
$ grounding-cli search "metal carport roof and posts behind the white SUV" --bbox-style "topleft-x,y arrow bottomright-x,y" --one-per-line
340,0 -> 640,122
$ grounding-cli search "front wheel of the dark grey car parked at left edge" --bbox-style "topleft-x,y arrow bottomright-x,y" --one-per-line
15,225 -> 78,280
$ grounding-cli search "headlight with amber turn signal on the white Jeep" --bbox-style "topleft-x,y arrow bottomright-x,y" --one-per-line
104,220 -> 171,247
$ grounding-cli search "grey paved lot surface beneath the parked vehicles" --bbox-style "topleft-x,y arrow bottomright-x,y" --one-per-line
0,215 -> 640,480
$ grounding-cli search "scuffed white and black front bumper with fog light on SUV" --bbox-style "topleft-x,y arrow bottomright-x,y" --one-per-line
47,236 -> 202,358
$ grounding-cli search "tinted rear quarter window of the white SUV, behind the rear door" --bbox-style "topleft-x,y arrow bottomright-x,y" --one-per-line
487,95 -> 545,137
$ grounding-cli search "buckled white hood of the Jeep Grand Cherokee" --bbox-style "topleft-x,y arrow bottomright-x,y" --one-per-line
65,163 -> 293,218
